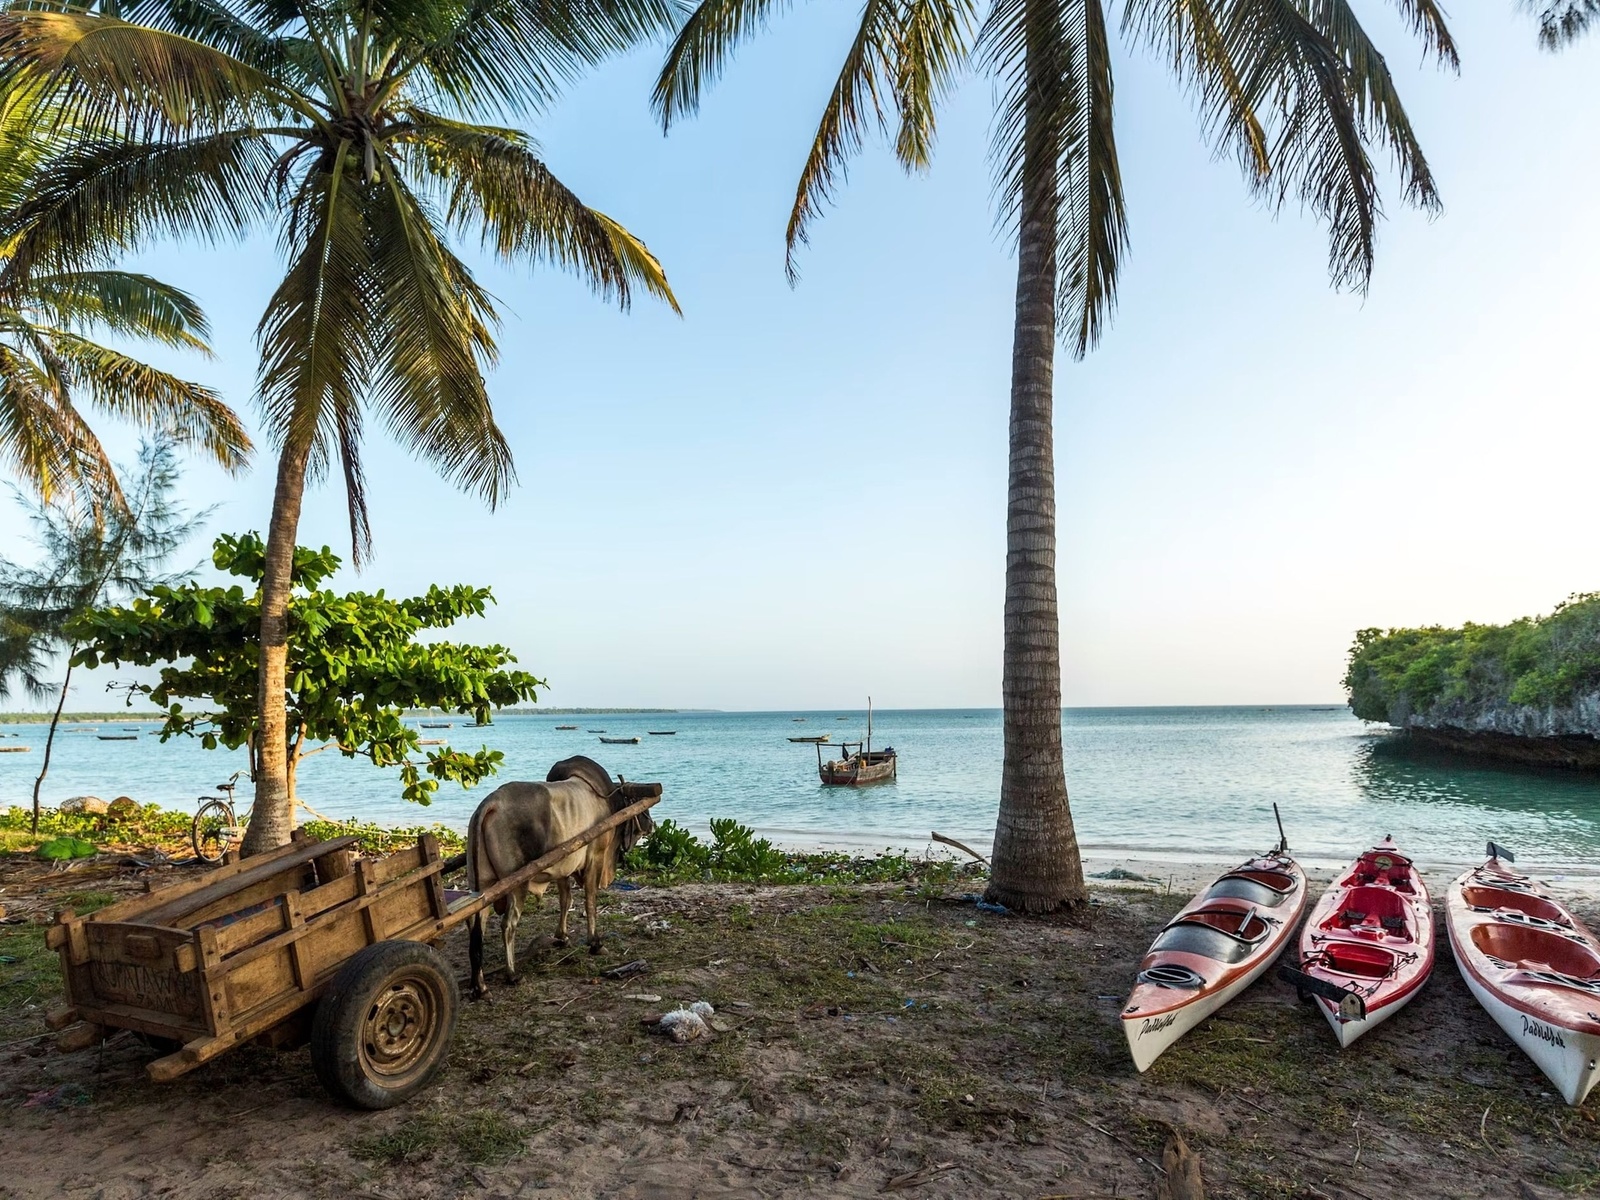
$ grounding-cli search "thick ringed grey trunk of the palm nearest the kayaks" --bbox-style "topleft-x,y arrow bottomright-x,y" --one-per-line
986,32 -> 1088,912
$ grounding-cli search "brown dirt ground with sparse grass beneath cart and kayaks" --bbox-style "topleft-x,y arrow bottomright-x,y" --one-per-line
0,862 -> 1600,1200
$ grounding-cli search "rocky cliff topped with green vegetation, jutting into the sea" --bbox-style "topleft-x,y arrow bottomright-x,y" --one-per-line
1344,592 -> 1600,770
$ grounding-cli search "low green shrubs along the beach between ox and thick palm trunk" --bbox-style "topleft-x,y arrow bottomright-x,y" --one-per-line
622,818 -> 981,883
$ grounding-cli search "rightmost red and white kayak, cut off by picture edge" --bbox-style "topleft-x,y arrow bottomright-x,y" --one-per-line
1445,842 -> 1600,1107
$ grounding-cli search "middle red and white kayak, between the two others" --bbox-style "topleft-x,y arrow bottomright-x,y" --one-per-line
1299,837 -> 1434,1046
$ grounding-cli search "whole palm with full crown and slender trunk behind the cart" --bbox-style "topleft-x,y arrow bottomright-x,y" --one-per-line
0,0 -> 677,853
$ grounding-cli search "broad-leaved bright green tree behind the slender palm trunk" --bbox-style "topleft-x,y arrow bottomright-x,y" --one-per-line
70,533 -> 544,826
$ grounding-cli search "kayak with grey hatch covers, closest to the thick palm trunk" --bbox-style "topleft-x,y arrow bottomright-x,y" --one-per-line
1122,846 -> 1306,1070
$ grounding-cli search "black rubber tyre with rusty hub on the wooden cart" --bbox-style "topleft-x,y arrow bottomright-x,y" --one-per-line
310,941 -> 461,1109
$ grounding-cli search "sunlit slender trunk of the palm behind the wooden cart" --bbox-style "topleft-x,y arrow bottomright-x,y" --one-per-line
240,434 -> 310,858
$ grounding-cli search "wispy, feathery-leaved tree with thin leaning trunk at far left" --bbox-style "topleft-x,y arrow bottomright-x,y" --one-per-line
0,440 -> 210,834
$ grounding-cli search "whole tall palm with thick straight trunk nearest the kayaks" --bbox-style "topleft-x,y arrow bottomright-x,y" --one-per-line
654,0 -> 1456,912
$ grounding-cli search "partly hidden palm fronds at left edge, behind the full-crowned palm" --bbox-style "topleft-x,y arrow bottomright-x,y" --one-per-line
0,91 -> 250,502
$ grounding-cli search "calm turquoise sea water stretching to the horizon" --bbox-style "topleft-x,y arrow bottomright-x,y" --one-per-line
0,707 -> 1600,870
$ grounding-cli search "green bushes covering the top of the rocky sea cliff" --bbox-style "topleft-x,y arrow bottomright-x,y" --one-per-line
1344,594 -> 1600,722
